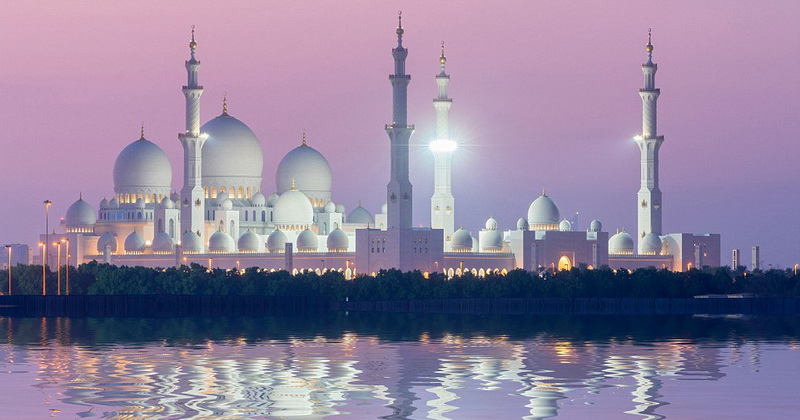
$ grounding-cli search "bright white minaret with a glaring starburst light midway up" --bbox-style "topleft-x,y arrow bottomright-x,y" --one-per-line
430,42 -> 456,246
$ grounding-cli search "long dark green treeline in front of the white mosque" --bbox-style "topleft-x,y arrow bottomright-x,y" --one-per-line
0,262 -> 800,301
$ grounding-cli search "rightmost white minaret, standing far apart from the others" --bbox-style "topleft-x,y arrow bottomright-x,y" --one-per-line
636,31 -> 664,252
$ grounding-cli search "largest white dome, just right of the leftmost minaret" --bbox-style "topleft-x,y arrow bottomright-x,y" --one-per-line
200,113 -> 264,190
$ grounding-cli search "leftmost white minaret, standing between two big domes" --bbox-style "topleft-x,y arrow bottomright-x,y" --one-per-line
178,25 -> 207,242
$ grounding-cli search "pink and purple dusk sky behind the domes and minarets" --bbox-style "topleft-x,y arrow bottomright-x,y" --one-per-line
0,0 -> 800,267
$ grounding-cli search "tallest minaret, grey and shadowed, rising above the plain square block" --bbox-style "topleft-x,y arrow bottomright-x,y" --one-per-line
386,12 -> 414,231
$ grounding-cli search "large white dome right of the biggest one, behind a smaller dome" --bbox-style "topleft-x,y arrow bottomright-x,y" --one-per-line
275,141 -> 333,200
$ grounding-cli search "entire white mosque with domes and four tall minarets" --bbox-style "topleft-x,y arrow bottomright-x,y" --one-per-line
50,17 -> 720,278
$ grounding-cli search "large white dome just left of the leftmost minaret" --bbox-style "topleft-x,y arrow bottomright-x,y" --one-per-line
114,137 -> 172,194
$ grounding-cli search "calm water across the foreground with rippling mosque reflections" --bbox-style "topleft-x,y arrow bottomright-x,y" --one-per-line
0,313 -> 800,419
